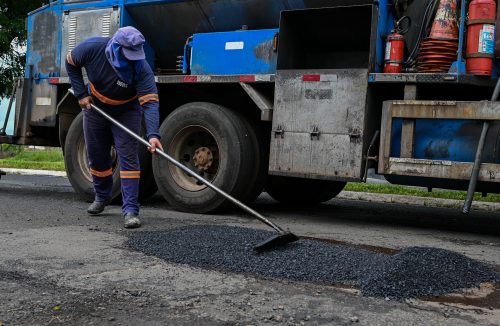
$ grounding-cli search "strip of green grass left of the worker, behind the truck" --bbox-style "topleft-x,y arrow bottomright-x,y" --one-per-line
0,148 -> 65,171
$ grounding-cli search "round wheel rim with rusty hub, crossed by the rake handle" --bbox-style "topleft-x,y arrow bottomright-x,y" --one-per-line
169,125 -> 220,192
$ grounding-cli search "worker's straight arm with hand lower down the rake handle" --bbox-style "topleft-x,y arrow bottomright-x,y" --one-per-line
136,61 -> 163,152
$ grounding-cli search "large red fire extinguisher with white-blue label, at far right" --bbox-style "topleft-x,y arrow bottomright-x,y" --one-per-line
466,0 -> 496,76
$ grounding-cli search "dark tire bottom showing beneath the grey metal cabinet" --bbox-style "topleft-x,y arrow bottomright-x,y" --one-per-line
266,176 -> 346,205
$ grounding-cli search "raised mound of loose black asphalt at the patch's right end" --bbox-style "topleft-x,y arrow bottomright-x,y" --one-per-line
360,247 -> 500,299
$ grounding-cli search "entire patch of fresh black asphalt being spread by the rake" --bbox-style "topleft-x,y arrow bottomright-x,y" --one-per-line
128,225 -> 500,299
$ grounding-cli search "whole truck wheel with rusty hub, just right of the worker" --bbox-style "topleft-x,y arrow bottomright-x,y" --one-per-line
153,102 -> 258,213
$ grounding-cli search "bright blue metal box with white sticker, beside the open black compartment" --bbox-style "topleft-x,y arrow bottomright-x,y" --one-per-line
191,29 -> 278,75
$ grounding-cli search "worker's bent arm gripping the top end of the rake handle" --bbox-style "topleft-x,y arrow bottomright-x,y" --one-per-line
66,42 -> 92,108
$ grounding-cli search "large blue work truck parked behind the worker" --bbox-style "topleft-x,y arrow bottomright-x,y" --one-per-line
0,0 -> 500,213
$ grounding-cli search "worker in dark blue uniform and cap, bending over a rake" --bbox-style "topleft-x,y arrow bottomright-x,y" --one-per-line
66,27 -> 163,228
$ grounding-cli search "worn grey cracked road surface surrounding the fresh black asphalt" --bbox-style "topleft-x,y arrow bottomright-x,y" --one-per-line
0,175 -> 500,325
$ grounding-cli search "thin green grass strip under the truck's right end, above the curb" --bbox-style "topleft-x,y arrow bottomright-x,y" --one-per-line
344,183 -> 500,202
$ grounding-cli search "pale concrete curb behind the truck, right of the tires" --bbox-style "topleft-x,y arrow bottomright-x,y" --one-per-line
337,191 -> 500,212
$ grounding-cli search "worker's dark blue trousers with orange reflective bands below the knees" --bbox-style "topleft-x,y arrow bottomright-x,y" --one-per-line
83,106 -> 142,215
